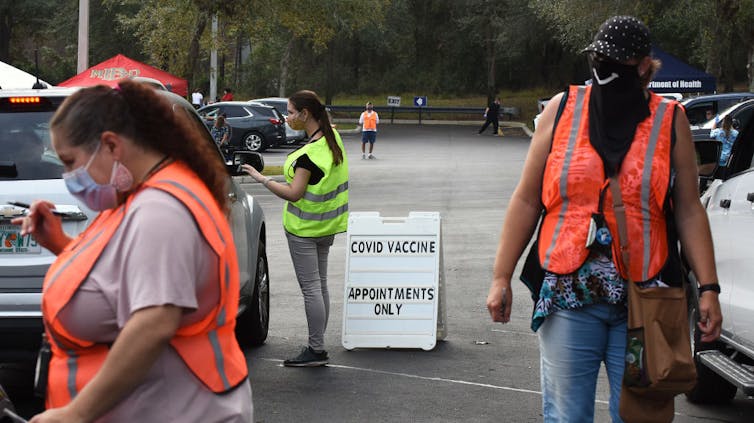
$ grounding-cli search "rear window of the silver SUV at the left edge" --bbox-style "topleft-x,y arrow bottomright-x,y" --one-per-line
0,111 -> 63,180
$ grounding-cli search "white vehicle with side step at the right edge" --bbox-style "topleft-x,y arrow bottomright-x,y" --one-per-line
686,124 -> 754,403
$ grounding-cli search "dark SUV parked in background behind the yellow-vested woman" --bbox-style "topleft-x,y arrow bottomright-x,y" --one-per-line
197,101 -> 285,152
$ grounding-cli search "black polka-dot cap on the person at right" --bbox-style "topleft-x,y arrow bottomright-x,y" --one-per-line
582,16 -> 652,62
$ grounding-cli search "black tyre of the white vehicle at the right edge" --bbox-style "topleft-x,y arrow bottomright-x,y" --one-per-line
686,276 -> 737,404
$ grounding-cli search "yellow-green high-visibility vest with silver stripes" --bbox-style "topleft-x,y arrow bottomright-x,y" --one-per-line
283,130 -> 348,238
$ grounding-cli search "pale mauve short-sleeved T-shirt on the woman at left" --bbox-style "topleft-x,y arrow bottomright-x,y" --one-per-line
60,189 -> 253,422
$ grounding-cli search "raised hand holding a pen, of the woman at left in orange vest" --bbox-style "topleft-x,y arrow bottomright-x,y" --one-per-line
11,200 -> 71,255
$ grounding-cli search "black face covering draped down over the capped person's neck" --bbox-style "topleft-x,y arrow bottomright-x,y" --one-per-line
589,58 -> 649,176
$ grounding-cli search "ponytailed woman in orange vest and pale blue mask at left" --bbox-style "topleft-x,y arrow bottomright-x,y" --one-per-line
13,80 -> 253,423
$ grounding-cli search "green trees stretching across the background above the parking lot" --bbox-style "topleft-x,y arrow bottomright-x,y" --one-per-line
0,0 -> 754,101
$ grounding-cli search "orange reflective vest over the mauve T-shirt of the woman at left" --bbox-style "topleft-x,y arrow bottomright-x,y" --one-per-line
42,162 -> 248,408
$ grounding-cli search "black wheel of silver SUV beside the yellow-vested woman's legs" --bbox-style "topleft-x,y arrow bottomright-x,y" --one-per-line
236,241 -> 270,347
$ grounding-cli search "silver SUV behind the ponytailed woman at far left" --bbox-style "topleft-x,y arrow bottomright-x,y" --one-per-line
0,88 -> 269,363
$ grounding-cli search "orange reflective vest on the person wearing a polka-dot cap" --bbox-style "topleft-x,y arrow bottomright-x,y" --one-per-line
538,86 -> 676,281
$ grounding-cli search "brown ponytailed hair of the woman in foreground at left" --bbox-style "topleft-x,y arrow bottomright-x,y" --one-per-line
50,80 -> 228,211
